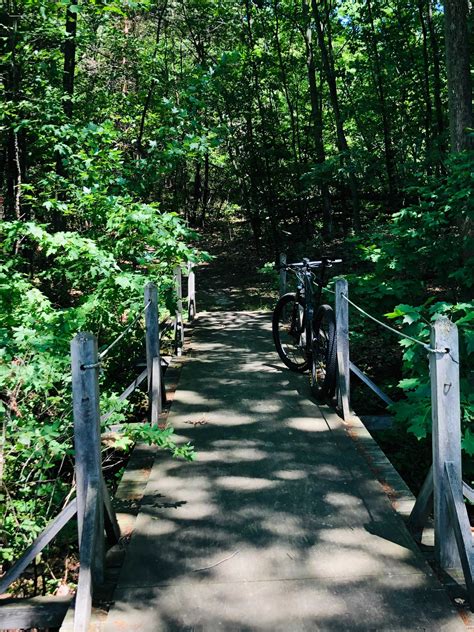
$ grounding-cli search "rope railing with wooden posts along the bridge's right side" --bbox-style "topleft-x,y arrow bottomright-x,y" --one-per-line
334,278 -> 474,609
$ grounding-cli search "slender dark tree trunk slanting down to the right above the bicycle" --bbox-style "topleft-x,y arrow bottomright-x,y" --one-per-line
311,0 -> 360,230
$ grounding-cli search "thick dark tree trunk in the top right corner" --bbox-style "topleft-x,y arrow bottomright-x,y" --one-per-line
444,0 -> 473,152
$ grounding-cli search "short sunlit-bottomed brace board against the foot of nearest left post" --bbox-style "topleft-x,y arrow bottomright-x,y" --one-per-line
74,480 -> 100,632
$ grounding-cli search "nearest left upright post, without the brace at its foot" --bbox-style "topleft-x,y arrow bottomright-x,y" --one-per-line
71,333 -> 105,583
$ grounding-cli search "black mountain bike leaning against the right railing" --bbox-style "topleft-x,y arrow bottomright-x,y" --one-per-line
272,258 -> 342,399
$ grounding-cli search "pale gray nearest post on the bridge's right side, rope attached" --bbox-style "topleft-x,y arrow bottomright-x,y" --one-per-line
430,316 -> 462,569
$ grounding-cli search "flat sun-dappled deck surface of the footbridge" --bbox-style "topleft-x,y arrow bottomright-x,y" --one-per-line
105,312 -> 465,632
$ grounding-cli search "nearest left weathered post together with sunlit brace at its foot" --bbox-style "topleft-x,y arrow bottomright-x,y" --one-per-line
71,333 -> 104,631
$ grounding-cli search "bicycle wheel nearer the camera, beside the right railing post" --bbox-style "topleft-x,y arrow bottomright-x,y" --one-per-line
309,305 -> 337,399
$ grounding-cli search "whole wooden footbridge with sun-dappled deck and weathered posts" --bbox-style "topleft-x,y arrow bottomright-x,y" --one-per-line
0,268 -> 473,632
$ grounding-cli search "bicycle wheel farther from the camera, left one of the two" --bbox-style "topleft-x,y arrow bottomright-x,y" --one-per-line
272,292 -> 309,373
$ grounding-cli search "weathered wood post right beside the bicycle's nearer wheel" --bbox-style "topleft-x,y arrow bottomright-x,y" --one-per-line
335,278 -> 351,419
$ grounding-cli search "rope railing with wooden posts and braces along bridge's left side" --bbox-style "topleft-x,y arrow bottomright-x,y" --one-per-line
0,265 -> 200,632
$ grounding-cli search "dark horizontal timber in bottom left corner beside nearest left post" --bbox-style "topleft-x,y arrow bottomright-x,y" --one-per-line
0,596 -> 71,630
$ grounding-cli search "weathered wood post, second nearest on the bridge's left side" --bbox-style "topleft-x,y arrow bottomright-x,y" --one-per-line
144,283 -> 163,426
